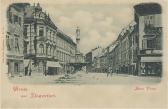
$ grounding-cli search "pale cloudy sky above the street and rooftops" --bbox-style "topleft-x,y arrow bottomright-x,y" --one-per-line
41,4 -> 134,54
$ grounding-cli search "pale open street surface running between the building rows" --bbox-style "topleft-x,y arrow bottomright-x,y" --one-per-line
9,71 -> 161,85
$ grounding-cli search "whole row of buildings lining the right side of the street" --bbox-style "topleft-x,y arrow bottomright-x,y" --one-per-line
86,3 -> 163,76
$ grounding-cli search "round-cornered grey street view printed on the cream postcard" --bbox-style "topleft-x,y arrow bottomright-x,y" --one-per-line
5,2 -> 163,85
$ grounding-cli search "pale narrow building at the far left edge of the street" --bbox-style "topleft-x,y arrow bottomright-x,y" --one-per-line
6,4 -> 24,76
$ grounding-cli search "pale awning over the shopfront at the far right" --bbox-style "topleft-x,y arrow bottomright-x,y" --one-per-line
141,57 -> 162,62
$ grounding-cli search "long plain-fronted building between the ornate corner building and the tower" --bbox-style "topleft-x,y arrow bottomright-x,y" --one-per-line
57,30 -> 76,72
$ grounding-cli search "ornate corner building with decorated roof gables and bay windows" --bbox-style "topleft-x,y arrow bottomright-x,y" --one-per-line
23,4 -> 60,74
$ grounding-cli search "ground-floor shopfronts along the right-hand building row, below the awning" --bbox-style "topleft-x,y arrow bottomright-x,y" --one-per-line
108,60 -> 162,76
